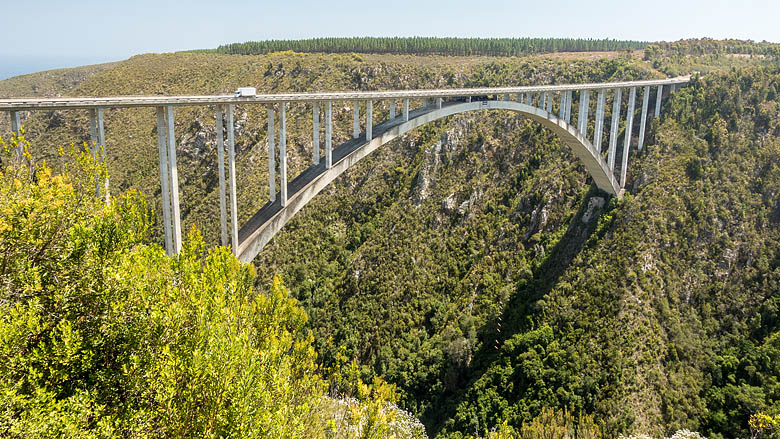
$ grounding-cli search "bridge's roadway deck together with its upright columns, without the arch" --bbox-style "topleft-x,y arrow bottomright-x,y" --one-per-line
0,77 -> 690,254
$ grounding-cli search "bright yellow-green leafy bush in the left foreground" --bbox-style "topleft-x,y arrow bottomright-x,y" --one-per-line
0,136 -> 425,438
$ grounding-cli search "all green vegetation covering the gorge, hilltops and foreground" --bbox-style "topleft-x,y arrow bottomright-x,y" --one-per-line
0,39 -> 780,439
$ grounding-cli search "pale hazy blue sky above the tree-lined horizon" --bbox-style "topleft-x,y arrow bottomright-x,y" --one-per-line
0,0 -> 780,78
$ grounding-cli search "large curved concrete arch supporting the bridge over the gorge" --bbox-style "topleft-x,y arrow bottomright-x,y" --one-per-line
235,100 -> 622,262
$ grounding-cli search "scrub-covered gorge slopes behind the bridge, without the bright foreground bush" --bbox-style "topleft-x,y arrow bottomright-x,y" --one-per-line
0,39 -> 780,438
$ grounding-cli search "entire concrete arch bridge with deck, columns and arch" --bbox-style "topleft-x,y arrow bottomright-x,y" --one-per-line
0,77 -> 690,262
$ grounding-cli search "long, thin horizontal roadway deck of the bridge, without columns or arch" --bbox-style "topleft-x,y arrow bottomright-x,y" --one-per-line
0,76 -> 690,111
